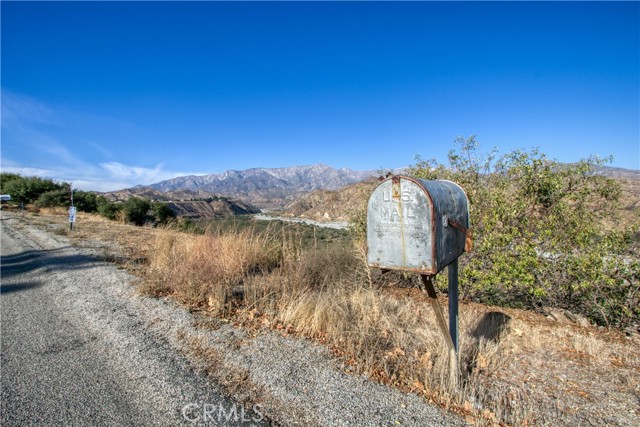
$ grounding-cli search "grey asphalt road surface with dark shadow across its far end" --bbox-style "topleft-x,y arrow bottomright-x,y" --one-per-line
0,217 -> 261,426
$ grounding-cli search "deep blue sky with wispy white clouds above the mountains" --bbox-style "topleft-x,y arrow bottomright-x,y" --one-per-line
0,1 -> 640,191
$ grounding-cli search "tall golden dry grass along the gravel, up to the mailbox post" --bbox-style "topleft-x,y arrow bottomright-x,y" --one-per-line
146,224 -> 536,419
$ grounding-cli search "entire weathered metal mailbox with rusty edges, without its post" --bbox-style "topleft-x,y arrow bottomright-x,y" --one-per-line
367,175 -> 471,276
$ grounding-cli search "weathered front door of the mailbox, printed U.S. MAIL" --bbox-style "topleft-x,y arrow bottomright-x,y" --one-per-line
367,176 -> 437,274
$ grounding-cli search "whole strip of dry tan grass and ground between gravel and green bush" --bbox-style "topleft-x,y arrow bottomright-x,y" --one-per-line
15,212 -> 640,425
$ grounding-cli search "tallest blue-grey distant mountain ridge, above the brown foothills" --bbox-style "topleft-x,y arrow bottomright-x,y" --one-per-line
144,164 -> 375,208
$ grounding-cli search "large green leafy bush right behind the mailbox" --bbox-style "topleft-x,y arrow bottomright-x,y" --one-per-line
409,136 -> 640,326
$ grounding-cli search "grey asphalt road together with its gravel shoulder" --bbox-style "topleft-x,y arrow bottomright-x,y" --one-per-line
0,212 -> 464,426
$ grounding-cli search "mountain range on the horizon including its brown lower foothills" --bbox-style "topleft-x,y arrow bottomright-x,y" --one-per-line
103,164 -> 640,220
